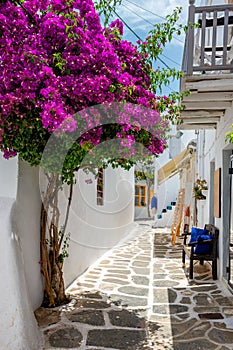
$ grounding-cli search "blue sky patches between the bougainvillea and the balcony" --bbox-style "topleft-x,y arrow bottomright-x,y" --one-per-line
107,0 -> 189,94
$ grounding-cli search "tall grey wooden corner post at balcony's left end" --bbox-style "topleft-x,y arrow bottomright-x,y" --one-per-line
187,0 -> 195,75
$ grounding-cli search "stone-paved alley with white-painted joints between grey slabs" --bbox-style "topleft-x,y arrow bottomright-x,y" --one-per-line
36,222 -> 233,350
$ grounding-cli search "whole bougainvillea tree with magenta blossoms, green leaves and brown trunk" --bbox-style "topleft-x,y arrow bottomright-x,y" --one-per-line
0,0 -> 186,306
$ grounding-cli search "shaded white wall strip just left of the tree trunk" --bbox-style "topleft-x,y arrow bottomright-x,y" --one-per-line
12,161 -> 43,310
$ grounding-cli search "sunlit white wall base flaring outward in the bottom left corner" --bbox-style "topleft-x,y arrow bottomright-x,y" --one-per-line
0,197 -> 41,350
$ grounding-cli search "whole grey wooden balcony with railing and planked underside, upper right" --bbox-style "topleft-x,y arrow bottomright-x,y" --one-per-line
179,0 -> 233,130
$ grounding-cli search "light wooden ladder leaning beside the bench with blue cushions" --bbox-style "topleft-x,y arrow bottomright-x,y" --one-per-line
171,188 -> 185,245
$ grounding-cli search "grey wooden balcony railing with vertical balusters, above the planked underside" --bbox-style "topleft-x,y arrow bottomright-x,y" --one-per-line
182,0 -> 233,75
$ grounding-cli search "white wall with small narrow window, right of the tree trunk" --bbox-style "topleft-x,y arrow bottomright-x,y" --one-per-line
64,167 -> 135,285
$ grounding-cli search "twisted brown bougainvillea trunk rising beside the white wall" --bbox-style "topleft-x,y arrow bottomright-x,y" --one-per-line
41,174 -> 72,307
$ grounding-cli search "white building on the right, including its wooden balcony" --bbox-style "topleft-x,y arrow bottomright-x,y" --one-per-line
179,0 -> 233,289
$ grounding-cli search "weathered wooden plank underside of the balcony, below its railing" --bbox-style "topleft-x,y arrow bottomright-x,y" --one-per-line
177,74 -> 233,130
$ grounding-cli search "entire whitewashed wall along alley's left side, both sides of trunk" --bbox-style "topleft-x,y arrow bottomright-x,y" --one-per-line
0,159 -> 134,350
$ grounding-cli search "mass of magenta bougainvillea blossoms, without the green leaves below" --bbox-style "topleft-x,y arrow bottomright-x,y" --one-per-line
0,0 -> 167,158
